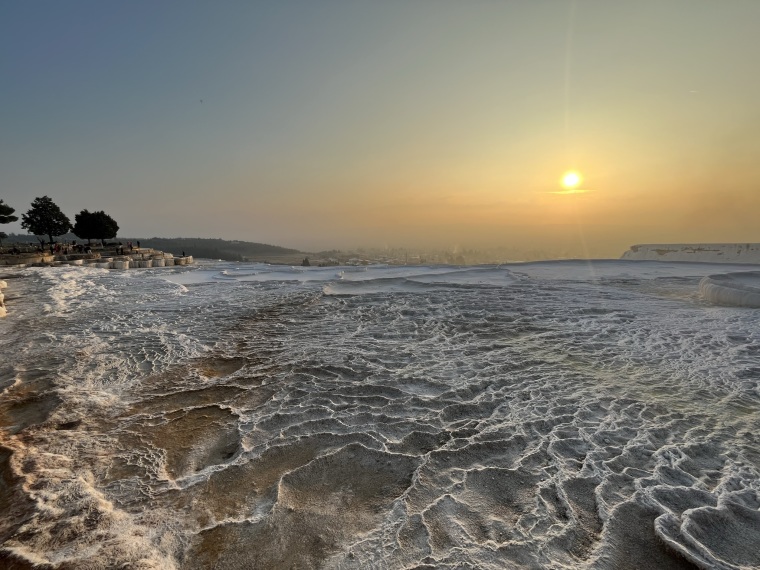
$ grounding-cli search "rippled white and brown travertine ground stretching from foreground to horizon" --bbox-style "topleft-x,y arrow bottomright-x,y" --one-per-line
0,262 -> 760,569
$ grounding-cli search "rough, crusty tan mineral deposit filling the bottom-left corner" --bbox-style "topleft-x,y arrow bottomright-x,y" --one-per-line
0,426 -> 179,570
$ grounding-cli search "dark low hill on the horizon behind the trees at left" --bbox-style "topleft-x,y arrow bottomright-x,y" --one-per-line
3,234 -> 301,261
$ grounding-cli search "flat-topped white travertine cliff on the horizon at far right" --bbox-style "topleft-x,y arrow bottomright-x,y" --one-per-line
621,243 -> 760,264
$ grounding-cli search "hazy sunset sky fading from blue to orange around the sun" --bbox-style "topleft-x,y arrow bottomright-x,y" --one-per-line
0,0 -> 760,257
